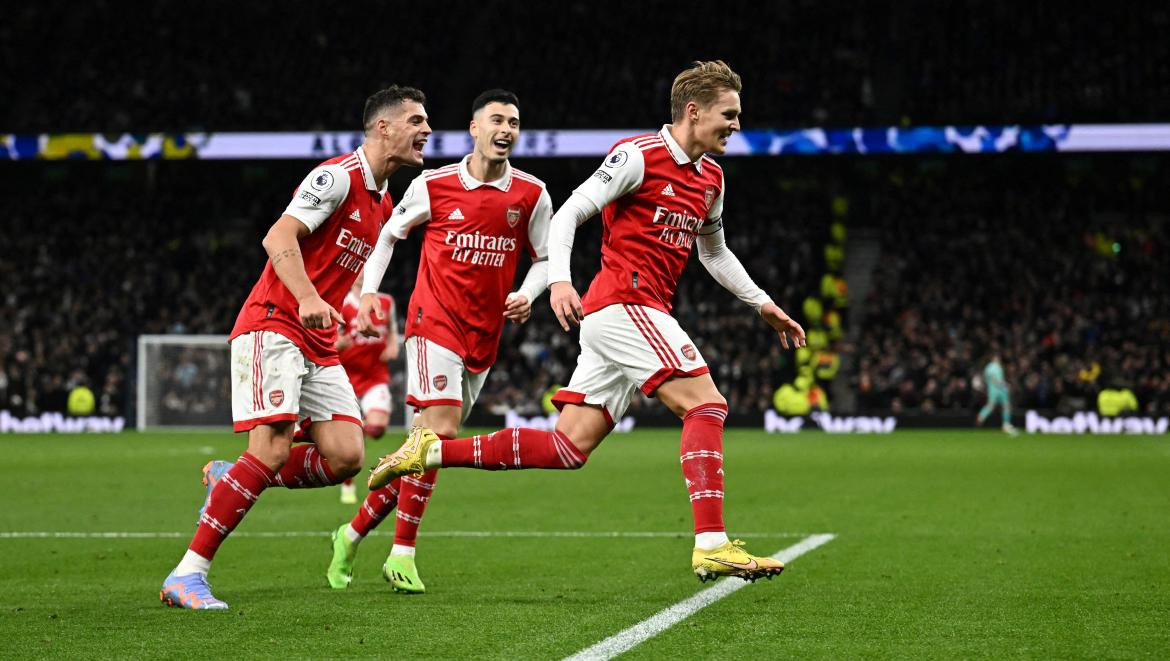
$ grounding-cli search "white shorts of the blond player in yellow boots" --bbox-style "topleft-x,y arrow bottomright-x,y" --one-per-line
552,304 -> 708,425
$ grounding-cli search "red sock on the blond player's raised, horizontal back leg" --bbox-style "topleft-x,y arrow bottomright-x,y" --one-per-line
442,427 -> 586,470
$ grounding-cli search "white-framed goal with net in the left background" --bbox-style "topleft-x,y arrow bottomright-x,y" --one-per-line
137,335 -> 232,429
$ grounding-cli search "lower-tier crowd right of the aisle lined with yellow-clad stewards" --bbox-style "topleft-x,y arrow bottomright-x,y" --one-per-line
855,157 -> 1170,414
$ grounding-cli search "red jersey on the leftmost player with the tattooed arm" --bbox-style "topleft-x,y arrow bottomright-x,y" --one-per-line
232,147 -> 394,365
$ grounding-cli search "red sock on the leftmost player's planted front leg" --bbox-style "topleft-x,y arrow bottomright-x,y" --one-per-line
188,453 -> 276,559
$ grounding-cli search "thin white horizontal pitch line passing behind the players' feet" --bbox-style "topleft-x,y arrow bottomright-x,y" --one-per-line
0,530 -> 808,539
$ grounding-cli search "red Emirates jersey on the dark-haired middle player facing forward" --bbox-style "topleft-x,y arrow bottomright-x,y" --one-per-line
390,158 -> 552,372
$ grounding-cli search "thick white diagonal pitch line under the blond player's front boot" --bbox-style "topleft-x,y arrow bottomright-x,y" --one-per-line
564,535 -> 835,661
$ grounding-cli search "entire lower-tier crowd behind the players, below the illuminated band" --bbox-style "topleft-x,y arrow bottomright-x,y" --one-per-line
0,156 -> 1170,414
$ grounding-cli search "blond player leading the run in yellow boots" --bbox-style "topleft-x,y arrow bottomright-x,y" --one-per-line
370,61 -> 805,580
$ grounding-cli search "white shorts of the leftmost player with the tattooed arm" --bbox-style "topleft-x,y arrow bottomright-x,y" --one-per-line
225,331 -> 362,432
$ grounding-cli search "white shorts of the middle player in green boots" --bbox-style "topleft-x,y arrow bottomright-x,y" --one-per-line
406,335 -> 490,424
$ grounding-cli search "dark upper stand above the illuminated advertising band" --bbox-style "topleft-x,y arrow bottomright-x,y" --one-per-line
0,0 -> 1170,132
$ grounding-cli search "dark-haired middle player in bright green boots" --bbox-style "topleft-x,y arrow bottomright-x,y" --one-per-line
326,89 -> 552,593
